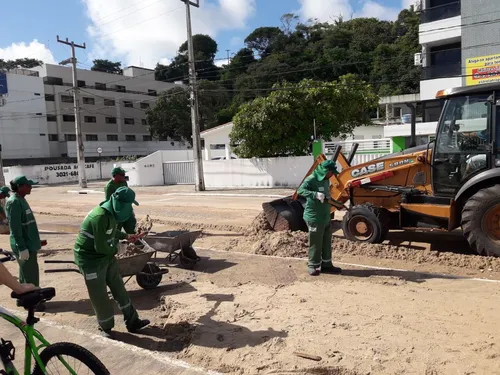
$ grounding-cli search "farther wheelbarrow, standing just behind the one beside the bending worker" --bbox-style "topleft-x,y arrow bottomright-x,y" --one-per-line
143,230 -> 201,269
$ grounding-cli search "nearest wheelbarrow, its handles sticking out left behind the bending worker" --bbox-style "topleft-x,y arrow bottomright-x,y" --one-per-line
44,244 -> 168,290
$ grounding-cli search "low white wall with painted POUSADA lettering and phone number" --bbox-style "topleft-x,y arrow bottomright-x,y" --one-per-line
3,162 -> 114,185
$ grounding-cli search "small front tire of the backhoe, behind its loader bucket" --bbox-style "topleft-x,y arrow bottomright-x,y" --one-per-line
342,204 -> 389,243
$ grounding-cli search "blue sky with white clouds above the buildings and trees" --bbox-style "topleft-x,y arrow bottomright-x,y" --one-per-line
0,0 -> 415,69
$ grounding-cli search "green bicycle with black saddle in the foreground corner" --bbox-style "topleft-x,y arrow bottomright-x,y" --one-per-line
0,250 -> 110,375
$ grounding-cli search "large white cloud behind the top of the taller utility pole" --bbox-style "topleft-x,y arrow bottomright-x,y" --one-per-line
83,0 -> 256,67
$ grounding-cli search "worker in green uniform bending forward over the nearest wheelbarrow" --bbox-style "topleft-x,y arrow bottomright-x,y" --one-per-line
74,186 -> 150,338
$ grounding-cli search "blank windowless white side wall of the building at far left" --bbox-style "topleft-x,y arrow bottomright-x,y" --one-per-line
0,73 -> 50,159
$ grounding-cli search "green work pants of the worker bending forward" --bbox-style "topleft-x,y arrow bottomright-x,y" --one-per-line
80,257 -> 139,331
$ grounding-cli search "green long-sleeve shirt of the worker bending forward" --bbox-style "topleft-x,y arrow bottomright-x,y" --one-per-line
74,206 -> 127,267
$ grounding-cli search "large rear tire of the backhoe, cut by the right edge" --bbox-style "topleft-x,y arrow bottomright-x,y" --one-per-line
462,185 -> 500,256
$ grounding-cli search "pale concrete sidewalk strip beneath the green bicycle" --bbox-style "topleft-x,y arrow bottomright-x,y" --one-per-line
0,312 -> 218,375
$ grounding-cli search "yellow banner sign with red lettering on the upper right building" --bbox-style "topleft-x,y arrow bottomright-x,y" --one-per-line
465,54 -> 500,86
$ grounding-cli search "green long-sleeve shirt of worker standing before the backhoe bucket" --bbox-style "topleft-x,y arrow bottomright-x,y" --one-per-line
297,174 -> 331,224
